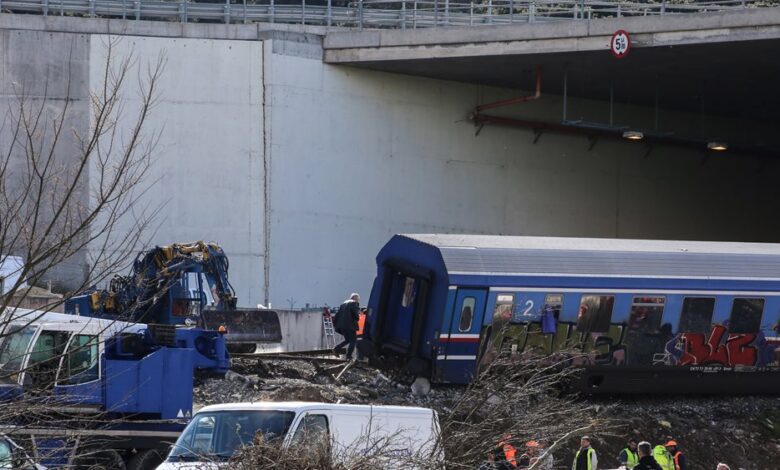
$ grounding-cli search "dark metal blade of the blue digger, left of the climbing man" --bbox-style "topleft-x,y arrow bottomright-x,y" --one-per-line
201,308 -> 282,344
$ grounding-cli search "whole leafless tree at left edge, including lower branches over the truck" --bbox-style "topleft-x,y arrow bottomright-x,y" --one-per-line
0,37 -> 165,468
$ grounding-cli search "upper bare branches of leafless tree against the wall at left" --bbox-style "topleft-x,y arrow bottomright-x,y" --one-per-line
0,38 -> 164,320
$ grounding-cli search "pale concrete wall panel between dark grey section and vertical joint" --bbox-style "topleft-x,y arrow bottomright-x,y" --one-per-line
89,34 -> 264,305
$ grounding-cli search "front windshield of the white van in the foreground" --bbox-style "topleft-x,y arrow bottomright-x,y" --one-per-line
168,410 -> 295,462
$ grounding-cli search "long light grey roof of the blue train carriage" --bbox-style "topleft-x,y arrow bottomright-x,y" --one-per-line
386,234 -> 780,284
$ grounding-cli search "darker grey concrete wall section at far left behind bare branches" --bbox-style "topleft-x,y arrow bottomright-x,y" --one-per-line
0,29 -> 89,287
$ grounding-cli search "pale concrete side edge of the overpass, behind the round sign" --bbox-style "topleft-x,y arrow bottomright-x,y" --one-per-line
324,8 -> 780,64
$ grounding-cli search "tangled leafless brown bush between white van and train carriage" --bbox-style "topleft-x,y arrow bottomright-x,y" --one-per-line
441,349 -> 616,469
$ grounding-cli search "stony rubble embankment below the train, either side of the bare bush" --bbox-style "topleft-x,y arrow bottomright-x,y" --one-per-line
194,358 -> 780,470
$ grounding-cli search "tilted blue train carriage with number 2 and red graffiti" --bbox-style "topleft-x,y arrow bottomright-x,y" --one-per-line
359,235 -> 780,393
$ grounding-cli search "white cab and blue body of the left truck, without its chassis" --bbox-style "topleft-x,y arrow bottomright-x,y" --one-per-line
0,309 -> 230,419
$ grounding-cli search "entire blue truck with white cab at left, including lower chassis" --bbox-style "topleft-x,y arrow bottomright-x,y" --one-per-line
0,309 -> 230,469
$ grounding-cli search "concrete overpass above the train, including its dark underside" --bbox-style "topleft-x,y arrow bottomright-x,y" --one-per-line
324,8 -> 780,125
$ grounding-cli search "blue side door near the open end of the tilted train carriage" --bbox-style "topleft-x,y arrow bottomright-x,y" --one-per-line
436,289 -> 487,383
